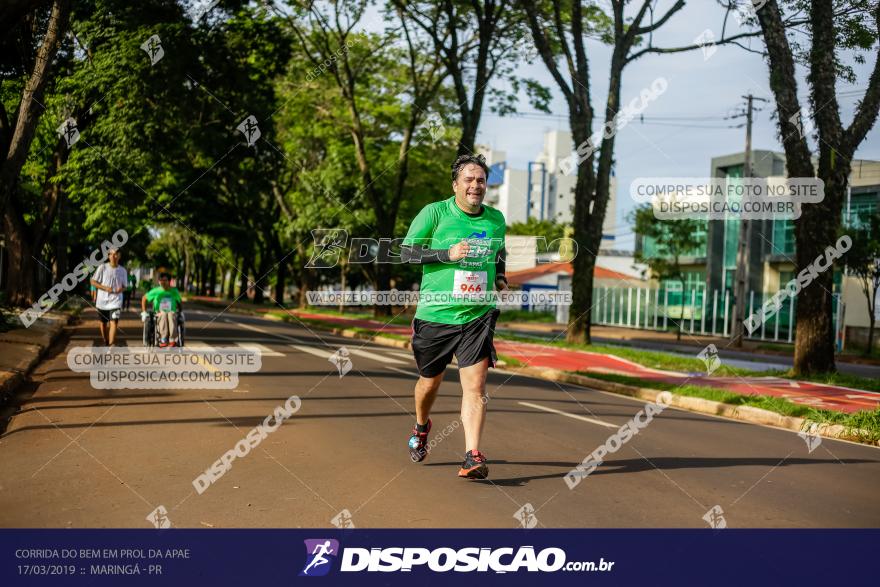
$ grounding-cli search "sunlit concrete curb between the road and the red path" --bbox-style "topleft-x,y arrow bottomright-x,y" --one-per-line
189,306 -> 880,446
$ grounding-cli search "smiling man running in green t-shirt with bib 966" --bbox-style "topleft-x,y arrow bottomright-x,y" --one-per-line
401,155 -> 507,479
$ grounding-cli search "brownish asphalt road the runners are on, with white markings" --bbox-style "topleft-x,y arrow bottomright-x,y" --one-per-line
0,309 -> 880,528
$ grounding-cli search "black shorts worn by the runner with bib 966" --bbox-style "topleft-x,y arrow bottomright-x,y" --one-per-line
412,310 -> 500,377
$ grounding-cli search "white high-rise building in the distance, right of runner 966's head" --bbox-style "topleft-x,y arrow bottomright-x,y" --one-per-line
478,130 -> 617,248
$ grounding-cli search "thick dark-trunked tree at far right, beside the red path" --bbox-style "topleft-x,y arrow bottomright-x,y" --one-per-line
755,0 -> 880,374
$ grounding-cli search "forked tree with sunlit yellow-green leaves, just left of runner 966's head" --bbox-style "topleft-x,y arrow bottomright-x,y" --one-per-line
278,0 -> 445,315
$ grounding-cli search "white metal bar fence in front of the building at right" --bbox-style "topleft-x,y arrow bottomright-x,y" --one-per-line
592,287 -> 839,342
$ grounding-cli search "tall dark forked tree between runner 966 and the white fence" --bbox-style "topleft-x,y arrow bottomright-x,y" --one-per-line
519,0 -> 802,343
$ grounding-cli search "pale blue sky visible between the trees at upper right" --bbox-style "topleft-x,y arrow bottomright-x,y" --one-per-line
477,0 -> 880,249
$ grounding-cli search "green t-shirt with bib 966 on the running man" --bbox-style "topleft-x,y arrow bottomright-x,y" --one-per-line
403,196 -> 507,324
